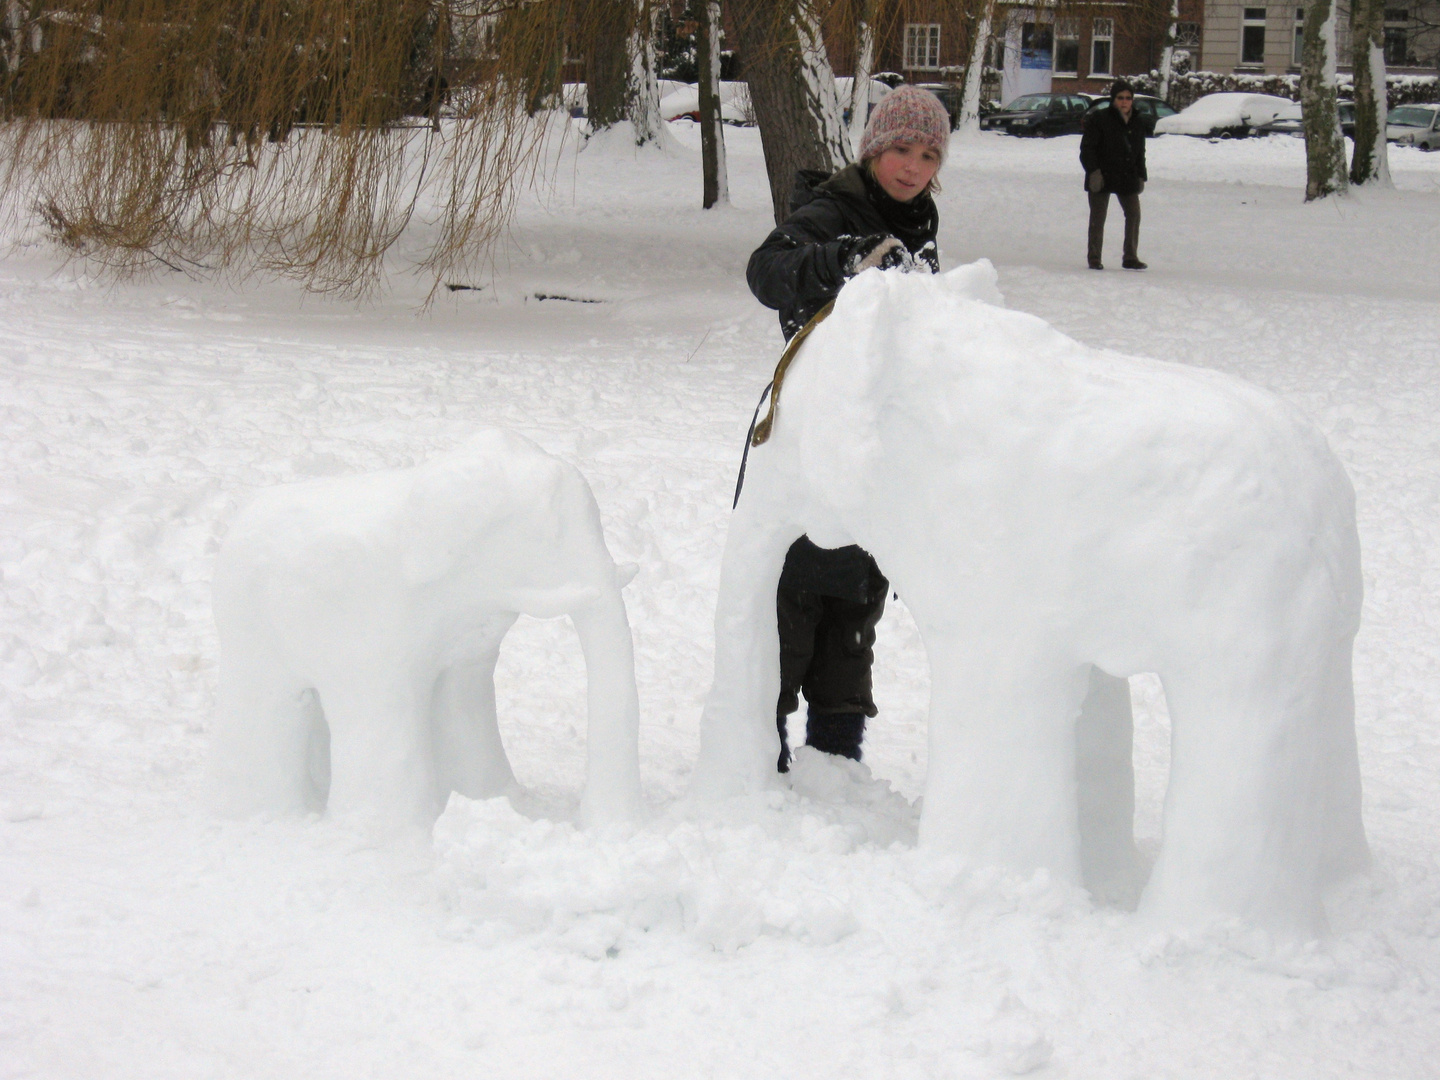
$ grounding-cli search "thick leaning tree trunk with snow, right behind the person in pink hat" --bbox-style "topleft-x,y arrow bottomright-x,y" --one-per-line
730,0 -> 850,222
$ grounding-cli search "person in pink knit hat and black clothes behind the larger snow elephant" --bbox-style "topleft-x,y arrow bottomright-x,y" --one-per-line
746,86 -> 950,772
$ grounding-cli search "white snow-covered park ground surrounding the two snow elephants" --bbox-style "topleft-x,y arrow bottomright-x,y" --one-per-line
0,124 -> 1440,1080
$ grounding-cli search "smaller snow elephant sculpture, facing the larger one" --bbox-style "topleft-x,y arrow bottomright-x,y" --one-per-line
210,431 -> 641,829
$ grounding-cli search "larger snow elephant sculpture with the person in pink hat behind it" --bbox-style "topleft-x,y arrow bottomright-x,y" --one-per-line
696,262 -> 1368,932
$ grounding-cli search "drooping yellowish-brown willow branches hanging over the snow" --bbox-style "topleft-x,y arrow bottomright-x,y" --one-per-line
0,0 -> 607,295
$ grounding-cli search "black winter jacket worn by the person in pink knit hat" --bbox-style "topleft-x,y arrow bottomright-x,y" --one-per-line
744,166 -> 940,341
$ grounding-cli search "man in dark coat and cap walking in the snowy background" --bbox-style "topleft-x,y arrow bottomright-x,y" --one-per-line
1080,79 -> 1149,269
